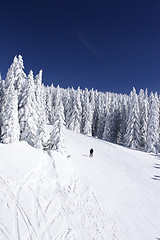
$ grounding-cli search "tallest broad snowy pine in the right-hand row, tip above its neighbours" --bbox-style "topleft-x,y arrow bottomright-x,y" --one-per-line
124,88 -> 141,149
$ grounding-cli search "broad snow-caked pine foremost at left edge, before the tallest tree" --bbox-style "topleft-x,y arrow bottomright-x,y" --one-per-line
1,76 -> 20,144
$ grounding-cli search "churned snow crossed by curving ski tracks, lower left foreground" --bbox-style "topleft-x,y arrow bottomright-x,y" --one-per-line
0,151 -> 117,240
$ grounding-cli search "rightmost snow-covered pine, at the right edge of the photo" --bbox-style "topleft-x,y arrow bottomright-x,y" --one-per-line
146,92 -> 159,153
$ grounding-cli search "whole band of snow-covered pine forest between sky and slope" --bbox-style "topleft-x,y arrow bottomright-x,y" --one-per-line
0,55 -> 160,153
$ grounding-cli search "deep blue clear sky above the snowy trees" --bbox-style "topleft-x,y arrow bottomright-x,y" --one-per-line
0,0 -> 160,94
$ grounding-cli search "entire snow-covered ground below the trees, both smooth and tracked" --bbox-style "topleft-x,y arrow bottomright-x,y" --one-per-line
0,130 -> 160,240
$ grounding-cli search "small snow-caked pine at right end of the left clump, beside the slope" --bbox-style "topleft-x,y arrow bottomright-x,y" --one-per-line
49,98 -> 65,153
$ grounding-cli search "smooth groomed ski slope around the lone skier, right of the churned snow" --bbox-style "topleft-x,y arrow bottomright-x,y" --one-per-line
66,131 -> 160,240
